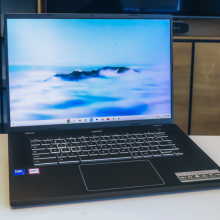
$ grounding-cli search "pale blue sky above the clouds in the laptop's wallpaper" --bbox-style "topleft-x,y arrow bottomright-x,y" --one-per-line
8,19 -> 170,66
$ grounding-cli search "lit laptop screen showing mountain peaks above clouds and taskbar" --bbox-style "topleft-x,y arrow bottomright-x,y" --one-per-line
7,19 -> 171,127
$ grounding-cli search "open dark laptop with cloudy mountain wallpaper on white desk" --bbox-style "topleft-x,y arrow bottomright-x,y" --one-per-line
5,14 -> 220,206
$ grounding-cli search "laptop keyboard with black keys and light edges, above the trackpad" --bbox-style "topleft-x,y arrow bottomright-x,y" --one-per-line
30,132 -> 183,166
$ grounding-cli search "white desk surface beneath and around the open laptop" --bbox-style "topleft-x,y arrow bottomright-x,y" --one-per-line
0,135 -> 220,220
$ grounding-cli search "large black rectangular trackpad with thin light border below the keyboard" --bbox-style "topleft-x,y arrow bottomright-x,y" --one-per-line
79,160 -> 164,191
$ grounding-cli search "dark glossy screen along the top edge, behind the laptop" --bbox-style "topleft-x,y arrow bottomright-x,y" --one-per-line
43,0 -> 220,17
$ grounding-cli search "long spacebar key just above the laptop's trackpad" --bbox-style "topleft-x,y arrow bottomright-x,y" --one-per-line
80,153 -> 132,163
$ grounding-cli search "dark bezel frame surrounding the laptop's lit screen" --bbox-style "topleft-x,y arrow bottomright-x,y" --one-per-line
4,14 -> 174,133
